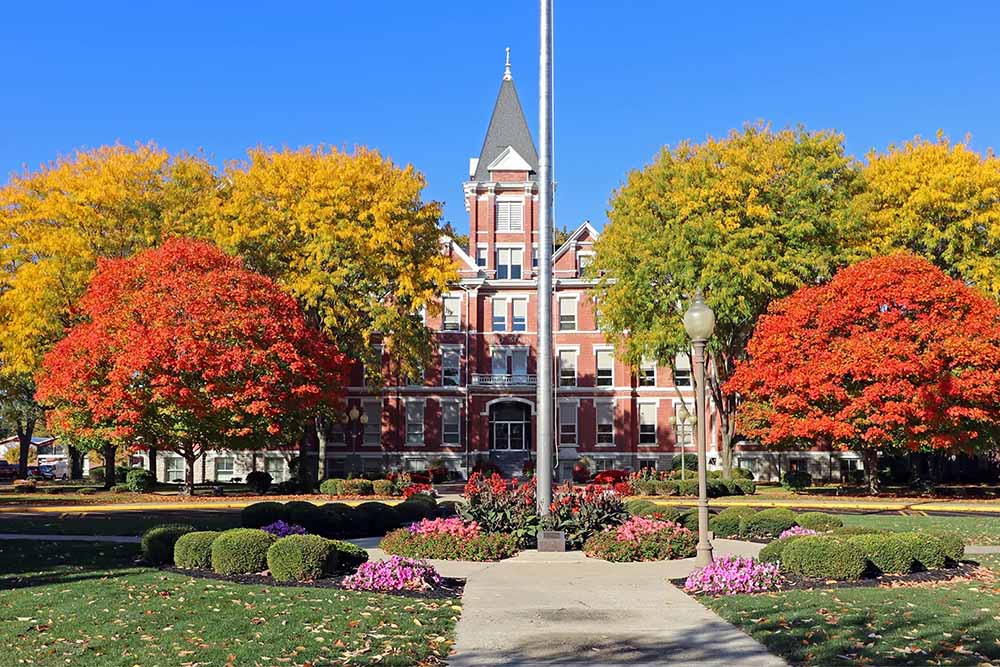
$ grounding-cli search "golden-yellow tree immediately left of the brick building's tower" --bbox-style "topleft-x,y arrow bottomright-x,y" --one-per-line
214,147 -> 453,477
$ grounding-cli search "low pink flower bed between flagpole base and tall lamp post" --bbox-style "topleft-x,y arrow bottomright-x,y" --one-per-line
583,516 -> 697,562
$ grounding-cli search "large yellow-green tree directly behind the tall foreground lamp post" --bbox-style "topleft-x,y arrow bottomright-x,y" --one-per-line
594,123 -> 861,476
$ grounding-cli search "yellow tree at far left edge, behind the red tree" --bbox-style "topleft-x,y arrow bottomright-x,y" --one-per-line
0,144 -> 217,474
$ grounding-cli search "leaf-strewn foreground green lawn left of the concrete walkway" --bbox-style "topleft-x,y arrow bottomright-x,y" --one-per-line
0,541 -> 461,667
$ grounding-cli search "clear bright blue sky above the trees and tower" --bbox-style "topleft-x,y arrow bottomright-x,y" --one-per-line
0,0 -> 1000,237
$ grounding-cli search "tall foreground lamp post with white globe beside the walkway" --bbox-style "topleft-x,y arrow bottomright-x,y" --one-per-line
684,290 -> 715,567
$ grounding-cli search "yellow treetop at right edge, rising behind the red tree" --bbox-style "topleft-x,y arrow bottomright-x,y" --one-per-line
855,133 -> 1000,298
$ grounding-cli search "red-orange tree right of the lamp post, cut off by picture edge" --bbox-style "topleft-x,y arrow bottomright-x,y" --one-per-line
726,255 -> 1000,491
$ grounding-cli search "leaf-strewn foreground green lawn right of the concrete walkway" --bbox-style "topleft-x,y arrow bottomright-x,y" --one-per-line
703,557 -> 1000,665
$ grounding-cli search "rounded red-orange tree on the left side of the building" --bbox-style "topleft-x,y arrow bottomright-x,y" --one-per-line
37,240 -> 346,490
